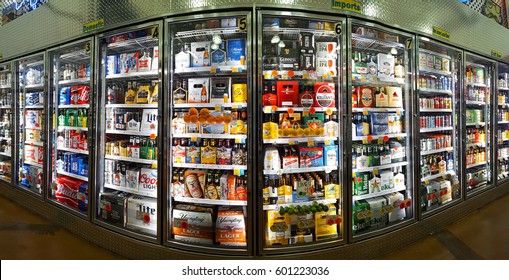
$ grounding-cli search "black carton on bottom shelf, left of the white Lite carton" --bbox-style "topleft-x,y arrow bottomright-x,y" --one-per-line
99,191 -> 127,227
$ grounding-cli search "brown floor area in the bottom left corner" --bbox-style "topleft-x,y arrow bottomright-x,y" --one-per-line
0,195 -> 122,260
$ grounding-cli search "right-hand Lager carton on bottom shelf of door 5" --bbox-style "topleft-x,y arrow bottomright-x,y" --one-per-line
216,206 -> 246,246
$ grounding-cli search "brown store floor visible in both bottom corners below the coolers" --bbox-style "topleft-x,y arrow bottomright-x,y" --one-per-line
0,192 -> 509,260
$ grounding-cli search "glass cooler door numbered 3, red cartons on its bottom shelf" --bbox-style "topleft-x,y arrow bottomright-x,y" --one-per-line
48,40 -> 93,215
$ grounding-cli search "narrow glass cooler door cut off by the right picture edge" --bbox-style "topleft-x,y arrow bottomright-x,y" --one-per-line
494,63 -> 509,183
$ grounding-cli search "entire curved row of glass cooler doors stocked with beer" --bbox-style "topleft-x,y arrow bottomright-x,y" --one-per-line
0,11 -> 509,254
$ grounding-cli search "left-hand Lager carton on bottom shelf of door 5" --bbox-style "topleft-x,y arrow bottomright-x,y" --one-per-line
172,204 -> 214,243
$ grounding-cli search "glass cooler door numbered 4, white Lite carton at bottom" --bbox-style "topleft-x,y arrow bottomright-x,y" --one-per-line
94,24 -> 161,240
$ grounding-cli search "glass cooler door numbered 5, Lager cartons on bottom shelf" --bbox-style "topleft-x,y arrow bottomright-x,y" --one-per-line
167,15 -> 253,251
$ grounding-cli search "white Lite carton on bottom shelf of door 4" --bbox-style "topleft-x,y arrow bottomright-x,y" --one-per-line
127,195 -> 157,235
